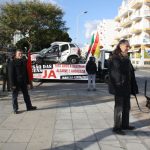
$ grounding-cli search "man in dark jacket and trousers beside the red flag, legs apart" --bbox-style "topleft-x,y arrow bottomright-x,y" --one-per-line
9,50 -> 36,114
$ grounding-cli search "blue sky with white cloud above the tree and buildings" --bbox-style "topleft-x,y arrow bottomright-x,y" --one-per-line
0,0 -> 122,44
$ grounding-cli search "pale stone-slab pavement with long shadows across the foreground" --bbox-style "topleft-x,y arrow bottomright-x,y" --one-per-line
0,83 -> 150,150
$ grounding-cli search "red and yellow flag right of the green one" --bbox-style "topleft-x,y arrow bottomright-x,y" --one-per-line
91,32 -> 100,58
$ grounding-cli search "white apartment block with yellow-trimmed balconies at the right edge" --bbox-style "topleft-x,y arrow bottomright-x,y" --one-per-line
115,0 -> 150,67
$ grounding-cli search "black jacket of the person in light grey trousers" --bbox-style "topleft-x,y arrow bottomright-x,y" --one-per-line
86,60 -> 97,74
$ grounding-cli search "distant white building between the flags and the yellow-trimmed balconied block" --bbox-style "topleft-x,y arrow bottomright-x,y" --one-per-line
97,19 -> 117,50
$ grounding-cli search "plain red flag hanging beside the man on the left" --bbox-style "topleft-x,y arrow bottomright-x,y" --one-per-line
27,50 -> 33,82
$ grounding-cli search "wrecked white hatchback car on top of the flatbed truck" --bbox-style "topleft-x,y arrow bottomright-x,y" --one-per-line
31,42 -> 81,64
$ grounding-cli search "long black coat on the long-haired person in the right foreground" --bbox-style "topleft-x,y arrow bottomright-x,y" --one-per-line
109,54 -> 138,96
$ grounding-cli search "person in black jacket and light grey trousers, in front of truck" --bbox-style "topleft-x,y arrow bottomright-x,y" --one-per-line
86,56 -> 97,91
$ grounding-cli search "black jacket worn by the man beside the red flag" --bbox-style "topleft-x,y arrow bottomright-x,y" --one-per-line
8,59 -> 29,87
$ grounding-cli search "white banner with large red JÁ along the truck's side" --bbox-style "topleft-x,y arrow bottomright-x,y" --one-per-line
32,64 -> 88,80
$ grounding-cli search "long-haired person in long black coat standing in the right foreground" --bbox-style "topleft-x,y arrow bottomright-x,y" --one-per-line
109,40 -> 138,135
